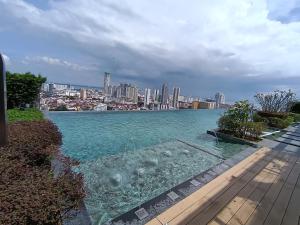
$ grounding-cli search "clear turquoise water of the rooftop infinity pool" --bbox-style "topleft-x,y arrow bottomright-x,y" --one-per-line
47,110 -> 247,221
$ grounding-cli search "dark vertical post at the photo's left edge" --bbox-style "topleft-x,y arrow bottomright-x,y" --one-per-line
0,53 -> 7,147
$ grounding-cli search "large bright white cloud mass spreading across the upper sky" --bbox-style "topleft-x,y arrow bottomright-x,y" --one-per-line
0,0 -> 300,79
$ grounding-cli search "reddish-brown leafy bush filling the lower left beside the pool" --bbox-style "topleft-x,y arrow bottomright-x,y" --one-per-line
0,121 -> 85,225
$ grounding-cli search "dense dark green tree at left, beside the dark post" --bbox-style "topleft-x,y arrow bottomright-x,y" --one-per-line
6,72 -> 46,109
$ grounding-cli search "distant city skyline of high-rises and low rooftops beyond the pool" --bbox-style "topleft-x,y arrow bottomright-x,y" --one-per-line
40,73 -> 230,111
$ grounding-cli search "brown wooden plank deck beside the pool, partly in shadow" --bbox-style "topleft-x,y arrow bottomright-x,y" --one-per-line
147,147 -> 300,225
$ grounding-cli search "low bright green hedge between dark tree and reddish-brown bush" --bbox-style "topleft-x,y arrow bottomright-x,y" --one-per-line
7,108 -> 44,123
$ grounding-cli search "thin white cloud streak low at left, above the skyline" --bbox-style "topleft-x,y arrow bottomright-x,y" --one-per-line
23,56 -> 97,71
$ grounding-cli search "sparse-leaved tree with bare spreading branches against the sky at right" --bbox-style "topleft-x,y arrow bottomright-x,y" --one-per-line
254,90 -> 295,112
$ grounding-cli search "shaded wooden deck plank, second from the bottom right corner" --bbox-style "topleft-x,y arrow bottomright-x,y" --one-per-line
264,156 -> 300,225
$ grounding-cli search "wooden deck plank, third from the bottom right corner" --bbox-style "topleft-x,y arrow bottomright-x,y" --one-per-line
246,156 -> 297,225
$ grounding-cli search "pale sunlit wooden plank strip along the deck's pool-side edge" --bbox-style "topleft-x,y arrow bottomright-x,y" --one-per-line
157,148 -> 270,224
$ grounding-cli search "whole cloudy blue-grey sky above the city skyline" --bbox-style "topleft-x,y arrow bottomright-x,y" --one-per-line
0,0 -> 300,101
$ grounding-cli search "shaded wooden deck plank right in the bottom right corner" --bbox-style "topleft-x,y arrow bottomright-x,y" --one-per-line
282,162 -> 300,225
